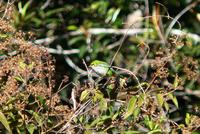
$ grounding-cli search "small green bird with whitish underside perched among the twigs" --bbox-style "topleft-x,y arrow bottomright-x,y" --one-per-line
89,60 -> 116,76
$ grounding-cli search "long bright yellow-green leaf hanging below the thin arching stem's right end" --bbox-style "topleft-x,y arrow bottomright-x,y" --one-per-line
124,96 -> 137,119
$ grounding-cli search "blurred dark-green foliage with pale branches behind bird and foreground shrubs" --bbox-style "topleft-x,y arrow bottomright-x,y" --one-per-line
2,0 -> 200,132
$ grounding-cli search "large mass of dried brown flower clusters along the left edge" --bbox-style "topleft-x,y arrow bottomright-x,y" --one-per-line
0,20 -> 68,132
